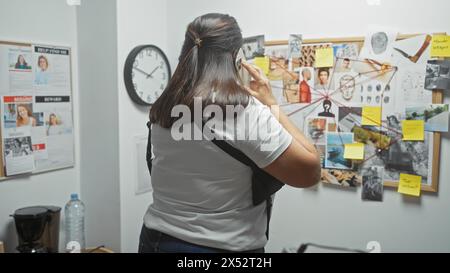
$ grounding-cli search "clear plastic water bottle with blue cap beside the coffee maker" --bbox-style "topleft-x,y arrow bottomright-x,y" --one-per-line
64,193 -> 85,253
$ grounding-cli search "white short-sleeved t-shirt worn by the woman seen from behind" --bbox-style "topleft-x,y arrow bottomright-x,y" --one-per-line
144,98 -> 292,251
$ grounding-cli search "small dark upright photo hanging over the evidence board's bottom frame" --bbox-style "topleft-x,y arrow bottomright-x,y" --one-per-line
361,166 -> 384,201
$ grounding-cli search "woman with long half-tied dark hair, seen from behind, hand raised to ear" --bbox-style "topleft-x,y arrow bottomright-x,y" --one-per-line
139,14 -> 320,253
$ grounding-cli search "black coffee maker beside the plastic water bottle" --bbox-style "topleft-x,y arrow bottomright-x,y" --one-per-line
12,206 -> 61,253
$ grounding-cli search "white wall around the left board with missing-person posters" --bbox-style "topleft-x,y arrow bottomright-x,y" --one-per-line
0,0 -> 80,252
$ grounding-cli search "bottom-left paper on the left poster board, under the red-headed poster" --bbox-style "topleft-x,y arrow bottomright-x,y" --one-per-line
3,136 -> 35,176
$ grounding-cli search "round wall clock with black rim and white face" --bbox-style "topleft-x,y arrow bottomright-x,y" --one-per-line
124,45 -> 170,105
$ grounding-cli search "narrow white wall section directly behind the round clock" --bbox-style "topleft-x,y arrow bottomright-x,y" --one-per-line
117,0 -> 170,252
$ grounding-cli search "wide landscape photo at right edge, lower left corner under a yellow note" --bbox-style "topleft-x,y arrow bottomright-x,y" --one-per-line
405,104 -> 449,132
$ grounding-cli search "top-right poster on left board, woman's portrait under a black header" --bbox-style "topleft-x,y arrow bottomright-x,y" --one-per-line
33,45 -> 71,95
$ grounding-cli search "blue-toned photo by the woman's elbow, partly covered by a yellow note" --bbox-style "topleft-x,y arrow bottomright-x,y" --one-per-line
325,133 -> 353,170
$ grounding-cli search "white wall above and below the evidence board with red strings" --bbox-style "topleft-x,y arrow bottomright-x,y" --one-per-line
167,0 -> 450,252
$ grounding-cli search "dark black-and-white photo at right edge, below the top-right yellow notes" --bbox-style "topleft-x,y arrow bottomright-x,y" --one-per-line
425,60 -> 450,90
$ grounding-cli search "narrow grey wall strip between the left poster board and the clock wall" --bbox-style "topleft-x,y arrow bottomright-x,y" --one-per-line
77,0 -> 120,251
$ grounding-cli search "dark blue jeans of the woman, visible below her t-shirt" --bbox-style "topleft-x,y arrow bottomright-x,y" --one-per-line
139,225 -> 264,253
